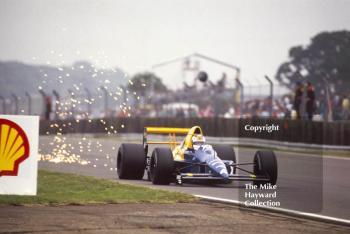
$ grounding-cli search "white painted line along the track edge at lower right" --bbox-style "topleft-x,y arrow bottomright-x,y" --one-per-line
194,195 -> 350,225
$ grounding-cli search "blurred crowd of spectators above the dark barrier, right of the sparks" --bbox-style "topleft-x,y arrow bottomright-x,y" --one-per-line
121,82 -> 350,121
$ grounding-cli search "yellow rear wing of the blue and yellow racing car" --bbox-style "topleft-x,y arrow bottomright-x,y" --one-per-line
142,127 -> 191,148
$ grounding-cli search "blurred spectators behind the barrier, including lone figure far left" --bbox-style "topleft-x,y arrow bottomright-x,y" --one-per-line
37,77 -> 350,121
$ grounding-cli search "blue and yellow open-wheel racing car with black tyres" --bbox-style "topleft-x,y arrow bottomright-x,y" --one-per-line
117,126 -> 277,186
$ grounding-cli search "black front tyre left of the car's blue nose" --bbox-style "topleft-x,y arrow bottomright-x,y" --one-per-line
149,148 -> 174,185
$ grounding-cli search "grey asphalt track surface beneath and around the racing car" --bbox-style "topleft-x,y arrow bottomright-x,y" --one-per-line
39,136 -> 350,220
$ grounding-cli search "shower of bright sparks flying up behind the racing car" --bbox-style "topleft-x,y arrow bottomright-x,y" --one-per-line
33,50 -> 142,171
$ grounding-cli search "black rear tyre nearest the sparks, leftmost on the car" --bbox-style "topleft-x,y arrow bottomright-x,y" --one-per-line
117,144 -> 146,180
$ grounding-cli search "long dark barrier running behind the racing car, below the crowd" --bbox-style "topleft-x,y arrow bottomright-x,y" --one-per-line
40,117 -> 350,146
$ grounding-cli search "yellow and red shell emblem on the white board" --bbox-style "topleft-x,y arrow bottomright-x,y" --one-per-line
0,119 -> 29,176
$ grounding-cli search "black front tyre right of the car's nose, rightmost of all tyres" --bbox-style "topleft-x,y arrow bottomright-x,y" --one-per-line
254,150 -> 278,186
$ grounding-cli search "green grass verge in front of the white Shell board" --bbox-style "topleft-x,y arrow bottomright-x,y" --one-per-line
0,170 -> 196,205
